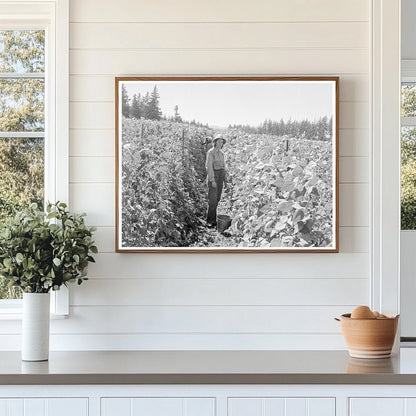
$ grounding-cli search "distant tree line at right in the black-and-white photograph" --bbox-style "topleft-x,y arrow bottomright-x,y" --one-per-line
229,116 -> 333,141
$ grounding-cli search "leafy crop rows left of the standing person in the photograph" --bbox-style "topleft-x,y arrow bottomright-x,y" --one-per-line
121,118 -> 212,247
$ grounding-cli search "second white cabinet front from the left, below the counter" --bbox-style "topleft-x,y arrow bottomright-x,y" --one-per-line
101,397 -> 215,416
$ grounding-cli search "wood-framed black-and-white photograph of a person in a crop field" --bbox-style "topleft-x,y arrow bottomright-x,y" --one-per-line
115,77 -> 339,253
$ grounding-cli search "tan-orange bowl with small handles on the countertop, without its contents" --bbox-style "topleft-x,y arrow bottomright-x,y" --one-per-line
336,313 -> 399,358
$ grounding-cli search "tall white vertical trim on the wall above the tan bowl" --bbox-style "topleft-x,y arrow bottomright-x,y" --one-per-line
371,0 -> 401,313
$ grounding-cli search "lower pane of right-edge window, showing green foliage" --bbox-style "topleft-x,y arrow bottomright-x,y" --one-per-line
401,127 -> 416,230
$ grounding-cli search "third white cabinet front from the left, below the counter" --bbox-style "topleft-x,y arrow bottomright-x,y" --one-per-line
228,397 -> 335,416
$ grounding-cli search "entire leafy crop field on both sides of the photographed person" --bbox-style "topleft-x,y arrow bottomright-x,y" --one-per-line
121,118 -> 334,248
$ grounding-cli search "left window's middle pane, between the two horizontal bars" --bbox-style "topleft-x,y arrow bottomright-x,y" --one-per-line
0,79 -> 45,131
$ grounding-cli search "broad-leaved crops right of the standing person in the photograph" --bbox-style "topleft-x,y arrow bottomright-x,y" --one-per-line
223,131 -> 333,247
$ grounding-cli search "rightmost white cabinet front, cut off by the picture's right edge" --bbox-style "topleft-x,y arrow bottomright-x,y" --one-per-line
349,397 -> 416,416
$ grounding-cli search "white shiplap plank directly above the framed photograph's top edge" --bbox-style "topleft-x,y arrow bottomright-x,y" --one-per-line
69,48 -> 368,76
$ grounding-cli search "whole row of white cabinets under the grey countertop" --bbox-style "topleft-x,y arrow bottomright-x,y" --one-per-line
5,384 -> 416,416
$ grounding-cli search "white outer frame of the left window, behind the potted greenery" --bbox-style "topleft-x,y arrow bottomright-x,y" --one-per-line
0,0 -> 69,319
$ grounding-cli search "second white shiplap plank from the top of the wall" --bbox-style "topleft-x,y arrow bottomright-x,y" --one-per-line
70,22 -> 368,49
